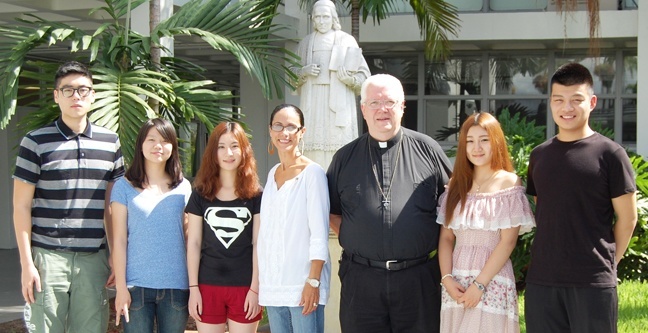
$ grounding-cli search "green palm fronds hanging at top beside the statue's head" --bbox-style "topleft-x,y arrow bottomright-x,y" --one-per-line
299,0 -> 459,60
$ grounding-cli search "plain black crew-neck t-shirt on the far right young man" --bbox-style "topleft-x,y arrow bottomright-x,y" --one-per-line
527,133 -> 636,288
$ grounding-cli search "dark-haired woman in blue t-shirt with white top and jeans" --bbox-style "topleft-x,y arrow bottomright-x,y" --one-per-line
110,119 -> 191,333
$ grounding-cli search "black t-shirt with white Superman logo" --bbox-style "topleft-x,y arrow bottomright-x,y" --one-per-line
185,191 -> 261,286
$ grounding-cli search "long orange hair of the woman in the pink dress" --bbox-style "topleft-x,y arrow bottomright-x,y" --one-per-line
444,111 -> 513,225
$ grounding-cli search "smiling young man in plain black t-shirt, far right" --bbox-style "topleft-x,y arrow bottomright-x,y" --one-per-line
525,63 -> 637,333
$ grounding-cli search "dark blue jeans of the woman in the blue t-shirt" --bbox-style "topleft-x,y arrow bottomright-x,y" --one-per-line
122,287 -> 189,333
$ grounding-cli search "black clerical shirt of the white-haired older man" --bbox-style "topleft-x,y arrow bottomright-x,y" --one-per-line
327,128 -> 452,260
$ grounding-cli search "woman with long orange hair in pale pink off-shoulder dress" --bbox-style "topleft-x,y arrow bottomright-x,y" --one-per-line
437,112 -> 534,333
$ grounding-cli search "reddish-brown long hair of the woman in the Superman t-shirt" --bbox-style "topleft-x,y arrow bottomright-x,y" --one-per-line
194,122 -> 261,200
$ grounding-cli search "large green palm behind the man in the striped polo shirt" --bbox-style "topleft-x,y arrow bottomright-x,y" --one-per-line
0,0 -> 296,160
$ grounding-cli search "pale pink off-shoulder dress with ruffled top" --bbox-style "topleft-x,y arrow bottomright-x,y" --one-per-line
437,186 -> 535,333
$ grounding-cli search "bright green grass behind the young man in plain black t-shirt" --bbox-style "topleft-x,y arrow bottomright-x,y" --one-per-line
518,281 -> 648,333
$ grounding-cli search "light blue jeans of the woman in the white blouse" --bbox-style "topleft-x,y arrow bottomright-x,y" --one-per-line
266,304 -> 324,333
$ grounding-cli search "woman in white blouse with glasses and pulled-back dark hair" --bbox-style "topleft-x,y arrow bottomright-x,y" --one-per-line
258,104 -> 331,333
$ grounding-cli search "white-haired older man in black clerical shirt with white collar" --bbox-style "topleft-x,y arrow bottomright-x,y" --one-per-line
327,74 -> 452,333
